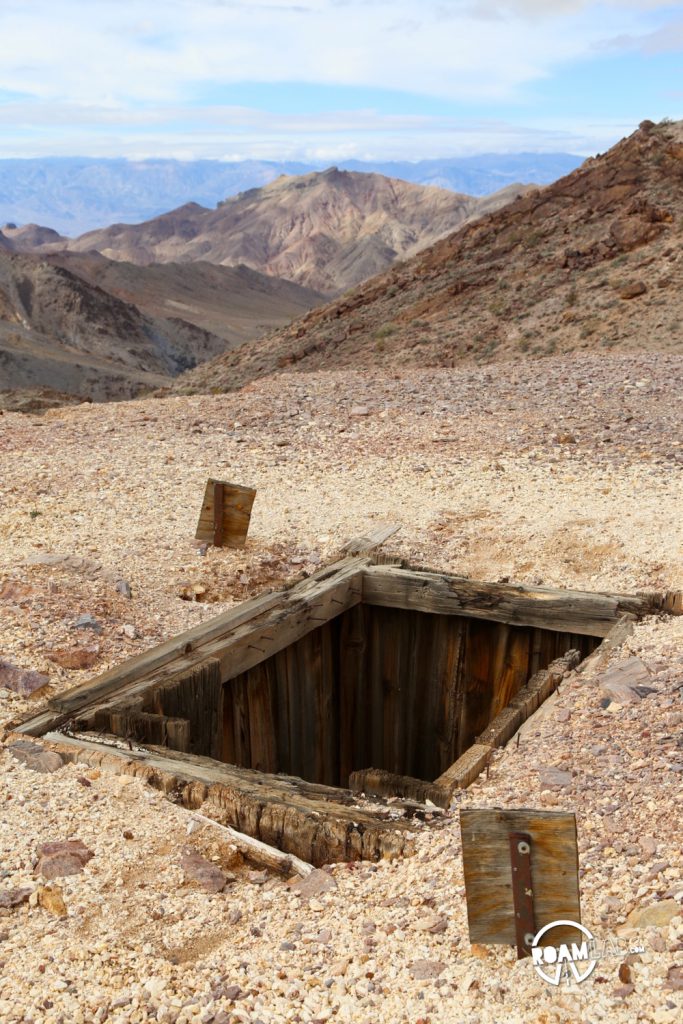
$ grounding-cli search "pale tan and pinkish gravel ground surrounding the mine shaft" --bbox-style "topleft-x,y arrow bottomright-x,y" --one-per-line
0,355 -> 683,1024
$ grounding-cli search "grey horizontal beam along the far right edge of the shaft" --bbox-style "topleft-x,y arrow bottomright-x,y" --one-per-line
362,565 -> 657,637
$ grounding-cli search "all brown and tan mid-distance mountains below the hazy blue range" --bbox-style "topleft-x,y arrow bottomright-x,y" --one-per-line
0,161 -> 540,409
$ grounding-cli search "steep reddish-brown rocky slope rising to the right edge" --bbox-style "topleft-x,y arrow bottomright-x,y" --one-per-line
177,122 -> 683,391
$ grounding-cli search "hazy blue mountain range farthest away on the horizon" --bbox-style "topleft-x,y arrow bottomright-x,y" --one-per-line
0,153 -> 583,237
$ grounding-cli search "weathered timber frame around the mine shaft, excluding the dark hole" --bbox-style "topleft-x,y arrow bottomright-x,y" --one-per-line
10,535 -> 681,865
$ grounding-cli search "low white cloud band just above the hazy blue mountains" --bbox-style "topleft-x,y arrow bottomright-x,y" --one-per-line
0,97 -> 635,162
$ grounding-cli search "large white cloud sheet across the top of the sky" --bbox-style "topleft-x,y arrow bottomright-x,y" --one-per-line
0,0 -> 665,104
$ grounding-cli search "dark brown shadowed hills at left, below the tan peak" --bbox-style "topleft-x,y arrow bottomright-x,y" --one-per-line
0,247 -> 321,408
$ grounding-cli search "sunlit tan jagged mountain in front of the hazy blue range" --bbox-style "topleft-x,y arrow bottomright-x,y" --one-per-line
40,167 -> 523,295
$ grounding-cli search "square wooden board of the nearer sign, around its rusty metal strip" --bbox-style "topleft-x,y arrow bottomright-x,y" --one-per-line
460,808 -> 581,945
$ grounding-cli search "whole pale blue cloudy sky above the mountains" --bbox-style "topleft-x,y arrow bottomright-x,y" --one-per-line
0,0 -> 683,160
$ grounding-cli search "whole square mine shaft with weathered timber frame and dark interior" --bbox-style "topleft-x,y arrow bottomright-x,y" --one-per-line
15,557 -> 671,865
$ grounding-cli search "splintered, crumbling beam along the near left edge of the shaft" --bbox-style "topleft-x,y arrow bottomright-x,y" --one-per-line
31,732 -> 418,867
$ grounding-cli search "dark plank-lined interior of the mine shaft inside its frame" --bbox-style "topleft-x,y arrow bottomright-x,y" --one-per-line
216,603 -> 601,786
